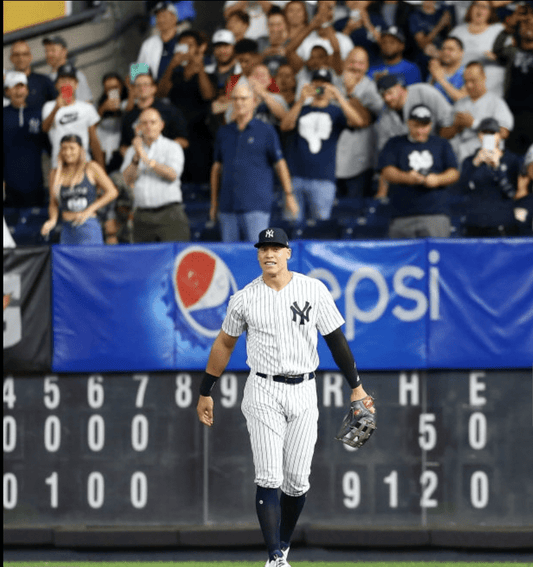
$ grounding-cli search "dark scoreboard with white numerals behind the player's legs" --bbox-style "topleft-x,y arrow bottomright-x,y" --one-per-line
3,370 -> 533,531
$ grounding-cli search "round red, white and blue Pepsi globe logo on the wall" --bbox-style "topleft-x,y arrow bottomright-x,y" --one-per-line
172,246 -> 238,338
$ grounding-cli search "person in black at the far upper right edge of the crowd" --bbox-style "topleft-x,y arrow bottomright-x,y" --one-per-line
494,6 -> 533,154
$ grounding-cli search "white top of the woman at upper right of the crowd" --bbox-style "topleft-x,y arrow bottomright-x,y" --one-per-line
450,23 -> 505,96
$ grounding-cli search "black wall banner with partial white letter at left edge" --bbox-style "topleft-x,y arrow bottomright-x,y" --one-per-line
3,247 -> 52,373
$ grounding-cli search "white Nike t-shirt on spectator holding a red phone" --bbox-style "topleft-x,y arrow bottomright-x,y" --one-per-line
42,100 -> 100,167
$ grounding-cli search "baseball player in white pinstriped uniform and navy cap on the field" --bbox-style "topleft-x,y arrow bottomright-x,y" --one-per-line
197,228 -> 374,567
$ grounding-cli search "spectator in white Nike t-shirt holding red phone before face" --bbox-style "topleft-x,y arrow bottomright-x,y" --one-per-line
42,63 -> 105,168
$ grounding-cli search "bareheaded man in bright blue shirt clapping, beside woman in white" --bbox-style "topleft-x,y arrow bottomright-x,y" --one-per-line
428,36 -> 466,104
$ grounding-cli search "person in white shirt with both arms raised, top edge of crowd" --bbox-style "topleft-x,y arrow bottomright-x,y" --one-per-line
286,0 -> 353,75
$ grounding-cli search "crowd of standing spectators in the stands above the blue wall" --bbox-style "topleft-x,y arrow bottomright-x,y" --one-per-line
3,0 -> 533,246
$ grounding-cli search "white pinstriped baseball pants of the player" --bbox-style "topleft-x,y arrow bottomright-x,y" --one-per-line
241,373 -> 318,496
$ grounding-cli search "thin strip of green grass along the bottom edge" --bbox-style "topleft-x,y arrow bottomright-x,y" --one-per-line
4,561 -> 531,567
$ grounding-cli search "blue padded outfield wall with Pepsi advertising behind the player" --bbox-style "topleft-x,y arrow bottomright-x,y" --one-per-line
52,238 -> 533,372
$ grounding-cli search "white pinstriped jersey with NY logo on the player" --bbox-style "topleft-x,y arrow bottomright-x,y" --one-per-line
222,272 -> 344,375
